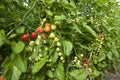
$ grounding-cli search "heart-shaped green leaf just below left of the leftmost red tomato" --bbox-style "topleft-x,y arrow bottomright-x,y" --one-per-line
11,41 -> 25,54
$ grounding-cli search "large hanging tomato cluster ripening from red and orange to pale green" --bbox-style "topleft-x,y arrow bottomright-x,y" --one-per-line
22,19 -> 65,73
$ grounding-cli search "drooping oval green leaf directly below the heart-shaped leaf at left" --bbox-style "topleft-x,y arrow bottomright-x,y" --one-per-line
14,54 -> 27,72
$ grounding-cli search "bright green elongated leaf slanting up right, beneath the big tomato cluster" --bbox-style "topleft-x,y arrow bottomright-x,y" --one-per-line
32,57 -> 47,74
